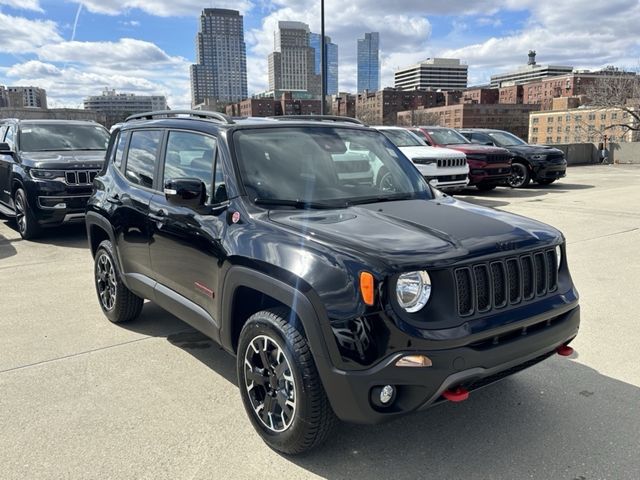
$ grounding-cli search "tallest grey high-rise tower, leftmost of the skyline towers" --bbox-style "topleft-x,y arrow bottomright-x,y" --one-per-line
191,8 -> 247,106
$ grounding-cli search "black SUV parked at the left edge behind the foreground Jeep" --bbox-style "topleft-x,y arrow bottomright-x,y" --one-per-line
0,119 -> 109,239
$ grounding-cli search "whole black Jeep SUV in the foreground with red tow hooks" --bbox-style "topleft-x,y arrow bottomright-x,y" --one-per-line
87,111 -> 580,453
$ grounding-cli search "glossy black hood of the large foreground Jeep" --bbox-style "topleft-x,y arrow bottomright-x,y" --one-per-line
269,197 -> 562,266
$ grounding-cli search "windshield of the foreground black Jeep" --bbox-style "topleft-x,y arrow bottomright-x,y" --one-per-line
233,126 -> 431,208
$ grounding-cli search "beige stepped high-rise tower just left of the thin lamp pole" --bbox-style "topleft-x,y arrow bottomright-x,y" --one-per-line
269,22 -> 321,95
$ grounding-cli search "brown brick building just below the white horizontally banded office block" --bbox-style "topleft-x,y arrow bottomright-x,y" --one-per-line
356,88 -> 444,125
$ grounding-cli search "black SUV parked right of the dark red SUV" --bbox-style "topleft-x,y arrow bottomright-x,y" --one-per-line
459,128 -> 567,188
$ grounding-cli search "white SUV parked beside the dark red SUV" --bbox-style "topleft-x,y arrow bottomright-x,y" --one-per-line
374,127 -> 469,191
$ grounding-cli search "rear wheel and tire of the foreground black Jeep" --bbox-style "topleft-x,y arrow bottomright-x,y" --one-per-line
93,240 -> 144,323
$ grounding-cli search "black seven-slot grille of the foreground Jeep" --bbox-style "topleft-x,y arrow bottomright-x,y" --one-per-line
454,250 -> 558,317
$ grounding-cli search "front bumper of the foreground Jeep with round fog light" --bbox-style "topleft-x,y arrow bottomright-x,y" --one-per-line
319,305 -> 580,423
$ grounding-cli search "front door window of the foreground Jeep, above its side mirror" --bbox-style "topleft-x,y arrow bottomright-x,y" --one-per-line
163,132 -> 217,203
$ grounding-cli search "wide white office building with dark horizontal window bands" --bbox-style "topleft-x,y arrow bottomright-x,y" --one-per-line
395,58 -> 469,90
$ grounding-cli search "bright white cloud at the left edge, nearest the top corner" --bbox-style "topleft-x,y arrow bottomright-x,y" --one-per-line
0,12 -> 62,54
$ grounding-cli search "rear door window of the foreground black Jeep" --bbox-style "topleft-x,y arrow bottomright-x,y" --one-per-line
125,130 -> 162,188
